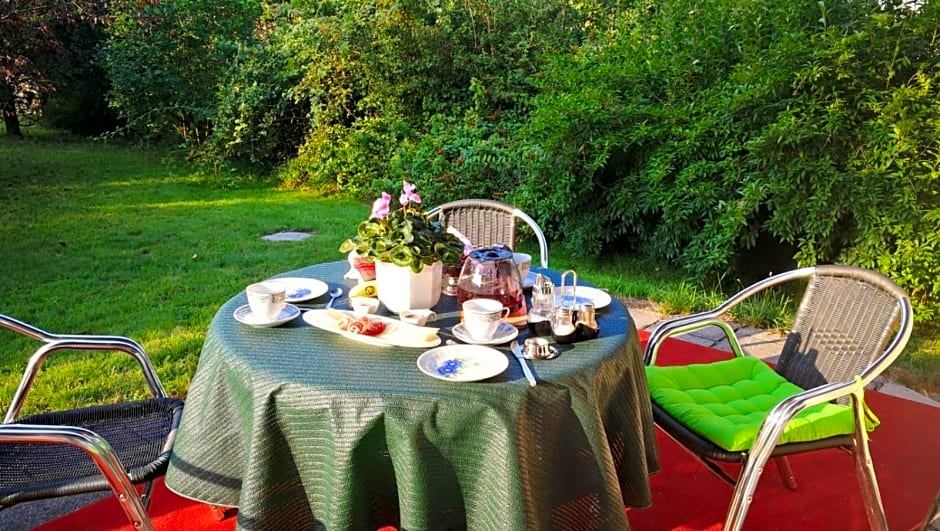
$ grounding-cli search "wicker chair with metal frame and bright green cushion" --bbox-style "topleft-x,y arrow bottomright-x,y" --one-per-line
645,266 -> 913,530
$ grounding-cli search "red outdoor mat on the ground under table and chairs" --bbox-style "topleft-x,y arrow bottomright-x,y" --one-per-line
37,334 -> 940,531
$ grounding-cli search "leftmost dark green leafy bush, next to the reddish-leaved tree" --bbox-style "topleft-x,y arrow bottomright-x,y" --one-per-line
102,0 -> 260,146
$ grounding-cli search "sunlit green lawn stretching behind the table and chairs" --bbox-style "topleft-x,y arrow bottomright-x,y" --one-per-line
0,131 -> 940,413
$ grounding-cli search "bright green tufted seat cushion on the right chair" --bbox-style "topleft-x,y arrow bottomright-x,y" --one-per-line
646,356 -> 874,451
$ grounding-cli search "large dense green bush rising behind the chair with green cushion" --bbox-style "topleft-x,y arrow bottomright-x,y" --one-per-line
515,1 -> 940,320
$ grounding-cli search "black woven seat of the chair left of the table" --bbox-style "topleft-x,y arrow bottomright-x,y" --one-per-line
0,398 -> 183,506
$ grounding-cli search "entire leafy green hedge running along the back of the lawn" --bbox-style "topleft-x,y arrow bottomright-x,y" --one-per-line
99,0 -> 940,321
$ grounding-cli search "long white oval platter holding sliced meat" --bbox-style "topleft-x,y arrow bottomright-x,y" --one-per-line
304,309 -> 441,348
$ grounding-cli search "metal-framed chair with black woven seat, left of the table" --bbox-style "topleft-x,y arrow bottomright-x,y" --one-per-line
0,314 -> 183,530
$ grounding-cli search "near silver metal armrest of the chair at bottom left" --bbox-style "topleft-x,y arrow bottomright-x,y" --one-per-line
0,424 -> 153,530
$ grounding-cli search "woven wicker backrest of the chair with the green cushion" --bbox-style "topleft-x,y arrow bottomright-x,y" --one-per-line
777,265 -> 913,389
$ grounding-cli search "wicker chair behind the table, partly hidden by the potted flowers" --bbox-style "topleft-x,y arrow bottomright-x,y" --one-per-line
428,199 -> 548,268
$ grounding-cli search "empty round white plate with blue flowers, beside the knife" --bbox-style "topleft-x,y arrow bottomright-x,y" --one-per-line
418,345 -> 509,382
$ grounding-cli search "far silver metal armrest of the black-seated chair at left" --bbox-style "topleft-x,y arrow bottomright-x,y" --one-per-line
3,335 -> 167,423
